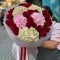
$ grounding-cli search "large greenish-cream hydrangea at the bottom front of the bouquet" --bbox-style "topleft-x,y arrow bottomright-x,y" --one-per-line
18,27 -> 39,42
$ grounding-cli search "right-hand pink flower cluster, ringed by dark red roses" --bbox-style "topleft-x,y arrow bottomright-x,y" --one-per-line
31,12 -> 45,27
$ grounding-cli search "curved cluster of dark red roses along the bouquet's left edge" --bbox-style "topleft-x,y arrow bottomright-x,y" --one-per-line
6,8 -> 19,35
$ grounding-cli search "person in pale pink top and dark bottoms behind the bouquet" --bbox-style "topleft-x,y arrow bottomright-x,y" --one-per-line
37,6 -> 60,60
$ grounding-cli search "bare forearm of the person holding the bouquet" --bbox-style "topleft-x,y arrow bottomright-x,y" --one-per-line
41,40 -> 59,49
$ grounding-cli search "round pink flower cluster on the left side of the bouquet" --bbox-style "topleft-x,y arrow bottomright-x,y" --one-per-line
13,14 -> 27,28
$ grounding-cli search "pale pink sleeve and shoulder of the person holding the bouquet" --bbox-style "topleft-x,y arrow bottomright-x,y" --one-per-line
51,22 -> 60,42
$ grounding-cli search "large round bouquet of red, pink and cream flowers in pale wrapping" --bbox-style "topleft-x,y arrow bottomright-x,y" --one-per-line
4,3 -> 52,59
